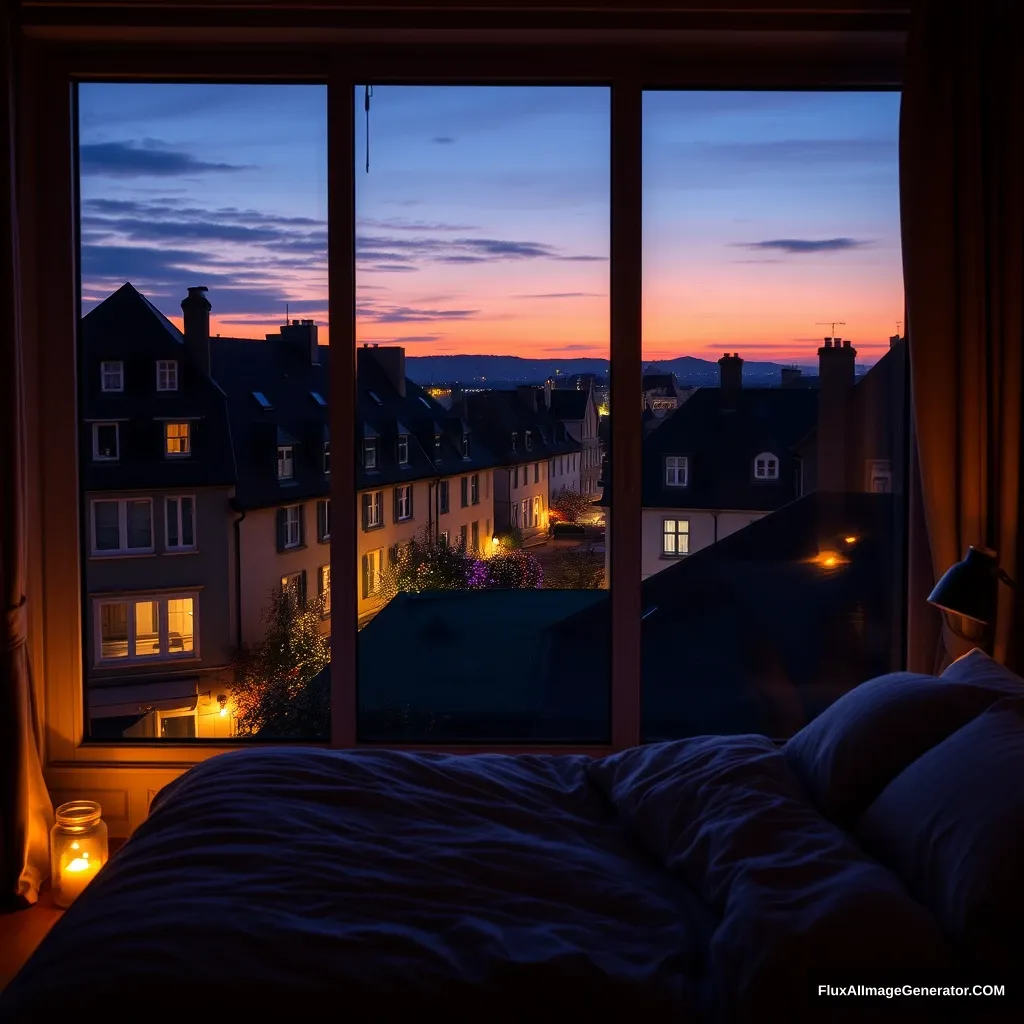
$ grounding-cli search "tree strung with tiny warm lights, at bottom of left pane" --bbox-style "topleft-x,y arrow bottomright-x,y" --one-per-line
231,590 -> 331,739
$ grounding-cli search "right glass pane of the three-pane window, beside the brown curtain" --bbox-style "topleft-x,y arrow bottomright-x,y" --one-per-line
642,91 -> 907,740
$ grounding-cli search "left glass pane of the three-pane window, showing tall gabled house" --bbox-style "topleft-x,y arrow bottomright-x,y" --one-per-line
77,82 -> 330,742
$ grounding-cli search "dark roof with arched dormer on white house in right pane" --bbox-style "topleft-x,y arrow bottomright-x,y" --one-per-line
642,387 -> 818,512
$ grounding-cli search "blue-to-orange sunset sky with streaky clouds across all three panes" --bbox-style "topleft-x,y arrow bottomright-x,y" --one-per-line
80,84 -> 903,362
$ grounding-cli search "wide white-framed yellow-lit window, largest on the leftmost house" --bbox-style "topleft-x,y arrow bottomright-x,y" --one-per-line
94,594 -> 199,662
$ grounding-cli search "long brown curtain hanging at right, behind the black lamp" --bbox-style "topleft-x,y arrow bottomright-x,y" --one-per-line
900,0 -> 1024,672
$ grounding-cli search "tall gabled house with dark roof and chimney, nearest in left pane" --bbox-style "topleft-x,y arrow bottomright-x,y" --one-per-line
79,284 -> 237,739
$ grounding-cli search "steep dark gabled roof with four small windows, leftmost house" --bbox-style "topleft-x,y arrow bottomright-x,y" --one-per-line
79,283 -> 237,490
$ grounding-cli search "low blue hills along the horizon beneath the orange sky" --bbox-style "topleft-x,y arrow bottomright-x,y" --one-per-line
406,355 -> 817,386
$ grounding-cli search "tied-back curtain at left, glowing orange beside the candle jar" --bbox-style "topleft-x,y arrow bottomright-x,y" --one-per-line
0,4 -> 53,905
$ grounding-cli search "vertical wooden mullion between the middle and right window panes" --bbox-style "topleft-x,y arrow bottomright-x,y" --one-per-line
608,79 -> 643,750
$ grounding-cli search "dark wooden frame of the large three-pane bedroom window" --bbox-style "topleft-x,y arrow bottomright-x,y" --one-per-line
17,25 -> 906,782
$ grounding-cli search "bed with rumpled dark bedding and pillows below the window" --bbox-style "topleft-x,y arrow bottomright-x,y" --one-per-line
0,651 -> 1024,1022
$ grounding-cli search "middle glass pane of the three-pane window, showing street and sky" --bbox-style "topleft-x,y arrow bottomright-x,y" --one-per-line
354,86 -> 610,743
